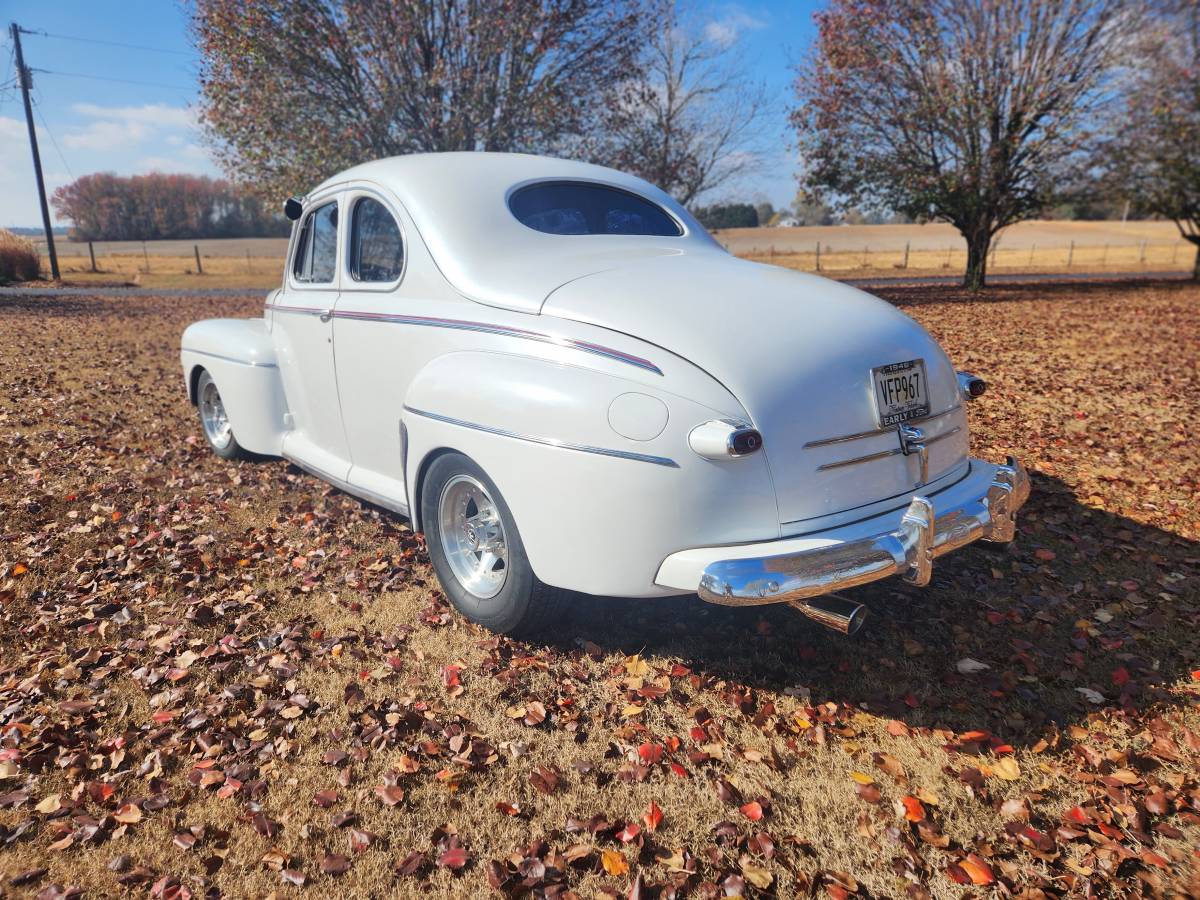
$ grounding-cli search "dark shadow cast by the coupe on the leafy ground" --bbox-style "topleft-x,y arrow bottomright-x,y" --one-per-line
550,474 -> 1200,744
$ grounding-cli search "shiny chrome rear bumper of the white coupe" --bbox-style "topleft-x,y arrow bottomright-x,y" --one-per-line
698,456 -> 1030,606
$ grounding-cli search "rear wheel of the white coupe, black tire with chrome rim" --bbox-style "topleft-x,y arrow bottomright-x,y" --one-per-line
421,452 -> 560,635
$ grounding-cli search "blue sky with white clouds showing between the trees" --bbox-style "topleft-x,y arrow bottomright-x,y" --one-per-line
0,0 -> 818,226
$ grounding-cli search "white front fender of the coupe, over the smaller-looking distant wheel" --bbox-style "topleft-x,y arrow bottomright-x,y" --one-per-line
179,319 -> 288,456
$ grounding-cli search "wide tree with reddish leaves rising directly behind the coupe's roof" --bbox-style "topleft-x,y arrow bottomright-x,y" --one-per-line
192,0 -> 649,197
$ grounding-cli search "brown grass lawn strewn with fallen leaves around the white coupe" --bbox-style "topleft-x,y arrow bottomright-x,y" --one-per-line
0,284 -> 1200,898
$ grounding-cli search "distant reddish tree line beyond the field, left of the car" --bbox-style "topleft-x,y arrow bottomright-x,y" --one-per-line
54,173 -> 290,240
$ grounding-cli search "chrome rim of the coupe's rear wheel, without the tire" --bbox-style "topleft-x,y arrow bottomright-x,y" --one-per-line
438,475 -> 509,600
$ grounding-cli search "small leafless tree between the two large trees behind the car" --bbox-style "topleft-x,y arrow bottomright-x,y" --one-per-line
597,4 -> 767,205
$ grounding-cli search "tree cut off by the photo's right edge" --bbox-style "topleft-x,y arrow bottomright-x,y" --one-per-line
1098,0 -> 1200,280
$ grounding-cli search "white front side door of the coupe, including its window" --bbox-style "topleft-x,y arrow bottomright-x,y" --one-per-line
271,192 -> 350,481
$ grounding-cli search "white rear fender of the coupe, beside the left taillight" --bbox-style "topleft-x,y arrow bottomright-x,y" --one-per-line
403,352 -> 779,596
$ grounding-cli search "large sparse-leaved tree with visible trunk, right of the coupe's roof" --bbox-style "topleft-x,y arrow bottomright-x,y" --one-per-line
792,0 -> 1133,289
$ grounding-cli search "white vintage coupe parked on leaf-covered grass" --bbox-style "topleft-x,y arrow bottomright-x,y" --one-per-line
181,152 -> 1028,632
